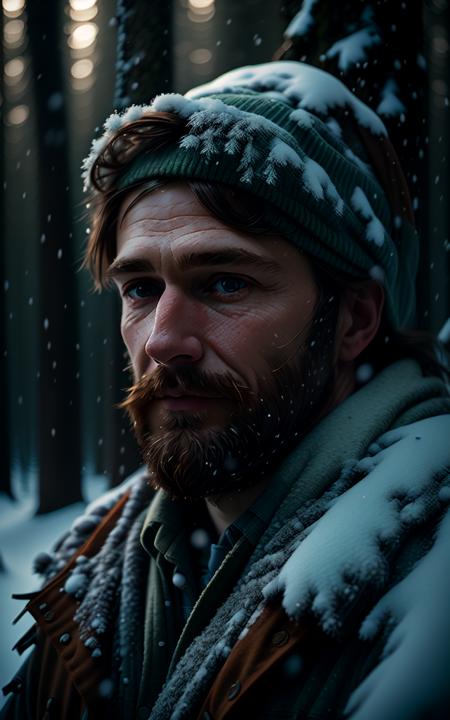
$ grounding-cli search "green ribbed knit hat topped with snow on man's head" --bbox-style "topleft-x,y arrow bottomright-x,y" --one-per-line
83,61 -> 418,327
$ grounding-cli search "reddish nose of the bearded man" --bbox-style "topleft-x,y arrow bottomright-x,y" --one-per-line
145,286 -> 203,365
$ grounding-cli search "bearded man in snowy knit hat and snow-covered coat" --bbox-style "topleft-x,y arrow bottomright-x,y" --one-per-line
3,62 -> 450,720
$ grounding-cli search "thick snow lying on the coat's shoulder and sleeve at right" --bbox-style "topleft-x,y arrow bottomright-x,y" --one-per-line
265,415 -> 450,720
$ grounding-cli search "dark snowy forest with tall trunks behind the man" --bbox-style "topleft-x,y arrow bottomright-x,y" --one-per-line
0,0 -> 450,513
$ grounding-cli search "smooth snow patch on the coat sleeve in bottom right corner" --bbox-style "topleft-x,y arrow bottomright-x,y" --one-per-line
346,506 -> 450,720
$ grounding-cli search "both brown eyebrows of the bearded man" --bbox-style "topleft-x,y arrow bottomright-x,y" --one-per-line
106,249 -> 281,280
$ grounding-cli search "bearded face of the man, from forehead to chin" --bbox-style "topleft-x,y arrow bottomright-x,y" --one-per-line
109,183 -> 332,496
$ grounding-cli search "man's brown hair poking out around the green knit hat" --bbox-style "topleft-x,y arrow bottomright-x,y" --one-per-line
83,112 -> 450,382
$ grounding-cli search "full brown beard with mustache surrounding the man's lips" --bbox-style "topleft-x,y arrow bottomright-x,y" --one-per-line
121,310 -> 334,500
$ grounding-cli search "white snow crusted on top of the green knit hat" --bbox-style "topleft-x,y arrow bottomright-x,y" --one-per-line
82,61 -> 385,202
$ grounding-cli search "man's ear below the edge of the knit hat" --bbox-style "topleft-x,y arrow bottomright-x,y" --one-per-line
335,281 -> 384,363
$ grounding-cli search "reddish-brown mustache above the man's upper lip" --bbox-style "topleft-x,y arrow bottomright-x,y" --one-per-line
118,365 -> 249,417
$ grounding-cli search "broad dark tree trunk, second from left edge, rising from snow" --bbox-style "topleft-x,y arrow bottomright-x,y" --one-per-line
28,0 -> 82,513
